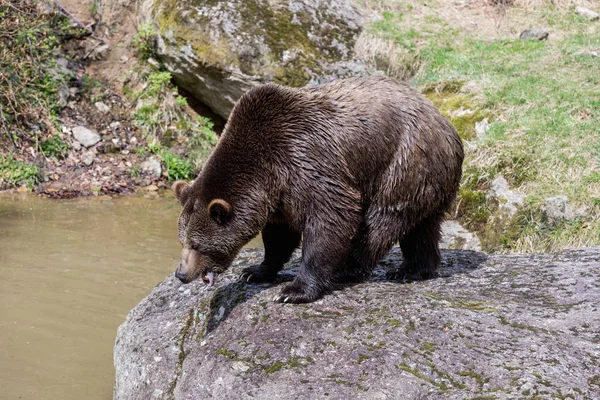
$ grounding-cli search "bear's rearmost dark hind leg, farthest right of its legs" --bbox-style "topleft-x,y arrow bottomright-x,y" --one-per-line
388,213 -> 443,281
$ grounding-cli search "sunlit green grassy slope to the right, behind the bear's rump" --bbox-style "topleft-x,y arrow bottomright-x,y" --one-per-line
367,1 -> 600,251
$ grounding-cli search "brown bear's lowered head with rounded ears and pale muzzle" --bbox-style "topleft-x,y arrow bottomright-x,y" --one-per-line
173,181 -> 249,285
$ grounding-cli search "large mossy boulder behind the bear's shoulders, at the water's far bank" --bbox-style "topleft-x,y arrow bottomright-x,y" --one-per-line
140,0 -> 368,118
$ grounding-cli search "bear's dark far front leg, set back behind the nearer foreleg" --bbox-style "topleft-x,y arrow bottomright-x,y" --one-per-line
240,223 -> 301,282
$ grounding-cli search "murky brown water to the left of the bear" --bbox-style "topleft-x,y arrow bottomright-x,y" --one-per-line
0,195 -> 261,400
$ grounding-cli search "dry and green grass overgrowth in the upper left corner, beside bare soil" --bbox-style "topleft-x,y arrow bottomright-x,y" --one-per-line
0,0 -> 84,141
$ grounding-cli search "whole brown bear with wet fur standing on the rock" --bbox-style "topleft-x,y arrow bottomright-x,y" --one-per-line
173,76 -> 463,303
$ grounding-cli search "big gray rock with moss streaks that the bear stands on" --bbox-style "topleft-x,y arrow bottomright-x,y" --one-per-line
114,248 -> 600,400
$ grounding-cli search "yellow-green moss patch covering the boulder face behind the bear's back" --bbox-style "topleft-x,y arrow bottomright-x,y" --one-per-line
153,0 -> 358,86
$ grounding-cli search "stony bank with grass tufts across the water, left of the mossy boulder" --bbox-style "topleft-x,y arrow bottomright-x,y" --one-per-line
0,0 -> 216,192
